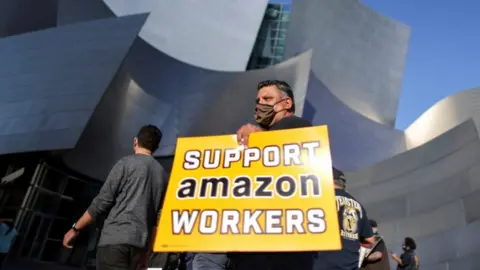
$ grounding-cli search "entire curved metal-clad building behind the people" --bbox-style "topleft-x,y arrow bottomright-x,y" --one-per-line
0,0 -> 480,270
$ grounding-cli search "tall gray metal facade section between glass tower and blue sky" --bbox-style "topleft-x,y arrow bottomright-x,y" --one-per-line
285,0 -> 410,127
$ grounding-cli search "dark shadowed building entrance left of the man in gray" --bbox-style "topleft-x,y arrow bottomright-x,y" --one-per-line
0,159 -> 101,268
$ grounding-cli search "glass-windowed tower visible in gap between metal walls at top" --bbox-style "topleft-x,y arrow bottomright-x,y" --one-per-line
248,3 -> 291,69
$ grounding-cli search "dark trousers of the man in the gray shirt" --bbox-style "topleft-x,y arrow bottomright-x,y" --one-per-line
97,245 -> 145,270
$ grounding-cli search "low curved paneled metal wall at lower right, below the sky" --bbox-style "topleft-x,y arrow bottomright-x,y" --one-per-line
347,119 -> 480,270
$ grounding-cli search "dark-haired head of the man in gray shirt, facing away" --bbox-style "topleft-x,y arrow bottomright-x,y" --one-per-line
133,125 -> 162,155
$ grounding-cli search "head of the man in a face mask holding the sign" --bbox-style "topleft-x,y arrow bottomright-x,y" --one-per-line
255,80 -> 295,128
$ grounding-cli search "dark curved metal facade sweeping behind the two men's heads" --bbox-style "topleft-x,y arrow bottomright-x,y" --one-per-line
65,39 -> 311,179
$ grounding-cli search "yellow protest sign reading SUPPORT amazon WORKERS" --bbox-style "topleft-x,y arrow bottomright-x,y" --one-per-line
154,126 -> 341,252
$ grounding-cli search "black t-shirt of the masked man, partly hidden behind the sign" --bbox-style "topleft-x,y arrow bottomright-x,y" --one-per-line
232,115 -> 314,270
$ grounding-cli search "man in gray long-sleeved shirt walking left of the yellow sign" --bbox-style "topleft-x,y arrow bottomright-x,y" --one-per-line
63,125 -> 168,270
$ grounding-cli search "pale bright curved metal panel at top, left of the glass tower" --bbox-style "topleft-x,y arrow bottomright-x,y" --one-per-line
104,0 -> 270,71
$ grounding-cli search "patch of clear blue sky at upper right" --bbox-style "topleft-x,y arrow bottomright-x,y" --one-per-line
271,0 -> 480,129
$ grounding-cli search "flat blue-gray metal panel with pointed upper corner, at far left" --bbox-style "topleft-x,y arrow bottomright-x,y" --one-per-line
0,15 -> 146,154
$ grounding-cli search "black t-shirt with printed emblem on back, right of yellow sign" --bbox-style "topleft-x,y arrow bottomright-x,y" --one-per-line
316,189 -> 373,270
